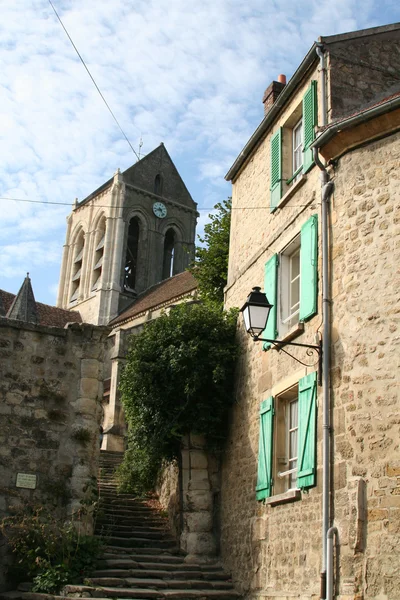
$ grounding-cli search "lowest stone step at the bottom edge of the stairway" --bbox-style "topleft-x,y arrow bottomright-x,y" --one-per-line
61,585 -> 239,600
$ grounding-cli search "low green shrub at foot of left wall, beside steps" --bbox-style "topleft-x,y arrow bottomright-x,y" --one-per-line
0,504 -> 101,593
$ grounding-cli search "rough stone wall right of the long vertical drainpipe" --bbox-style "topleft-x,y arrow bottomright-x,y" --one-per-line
332,134 -> 400,599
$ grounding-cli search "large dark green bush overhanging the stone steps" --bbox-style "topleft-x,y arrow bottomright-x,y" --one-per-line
119,304 -> 237,493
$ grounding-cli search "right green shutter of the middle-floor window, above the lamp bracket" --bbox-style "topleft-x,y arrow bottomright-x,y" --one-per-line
299,215 -> 318,321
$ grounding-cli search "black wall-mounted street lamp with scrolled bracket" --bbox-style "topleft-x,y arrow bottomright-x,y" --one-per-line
240,287 -> 322,379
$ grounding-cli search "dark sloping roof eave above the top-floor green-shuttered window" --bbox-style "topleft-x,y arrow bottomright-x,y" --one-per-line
225,42 -> 318,181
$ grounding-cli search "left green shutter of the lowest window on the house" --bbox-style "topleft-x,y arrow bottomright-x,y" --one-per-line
256,396 -> 274,500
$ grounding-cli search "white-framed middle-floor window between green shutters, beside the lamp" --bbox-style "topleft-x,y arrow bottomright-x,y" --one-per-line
277,234 -> 301,337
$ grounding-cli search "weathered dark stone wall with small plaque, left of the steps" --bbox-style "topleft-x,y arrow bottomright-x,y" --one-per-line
0,318 -> 108,589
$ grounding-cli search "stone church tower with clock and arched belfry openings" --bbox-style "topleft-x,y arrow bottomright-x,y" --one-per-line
57,144 -> 198,325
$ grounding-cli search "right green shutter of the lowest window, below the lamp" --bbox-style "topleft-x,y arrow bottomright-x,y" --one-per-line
297,372 -> 317,488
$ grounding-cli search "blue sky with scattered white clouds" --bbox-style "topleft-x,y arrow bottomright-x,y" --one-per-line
0,0 -> 400,305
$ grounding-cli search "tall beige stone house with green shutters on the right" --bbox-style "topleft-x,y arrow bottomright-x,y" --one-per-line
220,24 -> 400,600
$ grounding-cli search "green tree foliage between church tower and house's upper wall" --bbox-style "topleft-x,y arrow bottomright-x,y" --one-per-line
190,198 -> 232,306
